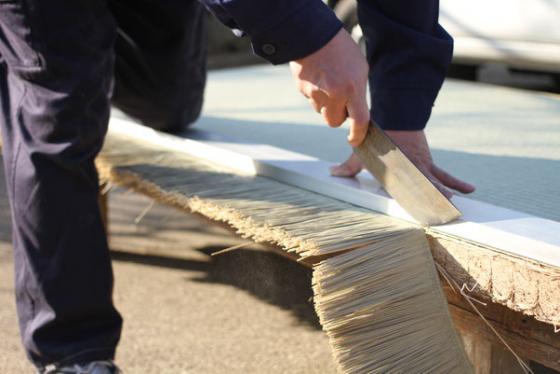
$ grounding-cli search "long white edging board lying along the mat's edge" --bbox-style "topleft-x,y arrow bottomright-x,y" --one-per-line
110,118 -> 560,268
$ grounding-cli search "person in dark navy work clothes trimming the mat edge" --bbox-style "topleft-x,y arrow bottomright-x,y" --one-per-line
0,0 -> 473,374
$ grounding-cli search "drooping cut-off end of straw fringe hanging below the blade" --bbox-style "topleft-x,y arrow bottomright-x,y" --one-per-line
313,228 -> 471,373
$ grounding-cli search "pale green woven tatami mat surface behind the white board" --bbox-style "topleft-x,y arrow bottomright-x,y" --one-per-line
185,66 -> 560,221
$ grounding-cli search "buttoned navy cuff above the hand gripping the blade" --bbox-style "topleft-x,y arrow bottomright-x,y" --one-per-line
252,0 -> 342,65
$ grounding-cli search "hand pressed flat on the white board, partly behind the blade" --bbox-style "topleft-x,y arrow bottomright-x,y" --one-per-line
331,131 -> 475,198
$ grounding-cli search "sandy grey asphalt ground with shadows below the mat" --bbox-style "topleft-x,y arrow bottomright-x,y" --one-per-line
0,159 -> 335,374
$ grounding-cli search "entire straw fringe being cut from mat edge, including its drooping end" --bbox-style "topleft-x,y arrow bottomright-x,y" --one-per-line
98,132 -> 472,373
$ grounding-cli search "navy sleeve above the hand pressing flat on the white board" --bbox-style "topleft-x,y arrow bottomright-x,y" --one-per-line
358,0 -> 453,130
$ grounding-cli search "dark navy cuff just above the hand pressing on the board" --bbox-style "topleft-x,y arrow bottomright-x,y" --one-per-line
371,89 -> 438,131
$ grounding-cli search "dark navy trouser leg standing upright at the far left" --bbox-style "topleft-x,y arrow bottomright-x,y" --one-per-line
0,0 -> 122,367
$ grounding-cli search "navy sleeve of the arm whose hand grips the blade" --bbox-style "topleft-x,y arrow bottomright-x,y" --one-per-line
201,0 -> 342,65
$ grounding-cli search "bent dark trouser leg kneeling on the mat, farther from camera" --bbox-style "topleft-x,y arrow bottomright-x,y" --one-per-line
109,0 -> 207,131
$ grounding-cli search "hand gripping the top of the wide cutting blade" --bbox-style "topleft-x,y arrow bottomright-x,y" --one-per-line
290,29 -> 369,146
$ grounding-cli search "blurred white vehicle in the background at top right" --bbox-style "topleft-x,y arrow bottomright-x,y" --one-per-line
330,0 -> 560,78
